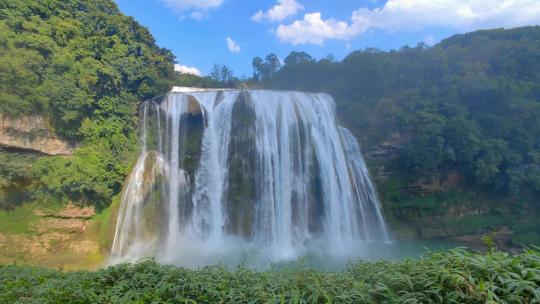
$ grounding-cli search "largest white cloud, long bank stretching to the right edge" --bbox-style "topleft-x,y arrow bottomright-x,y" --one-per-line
276,0 -> 540,45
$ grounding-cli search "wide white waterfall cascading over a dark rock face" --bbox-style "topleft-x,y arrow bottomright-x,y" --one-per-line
112,89 -> 389,266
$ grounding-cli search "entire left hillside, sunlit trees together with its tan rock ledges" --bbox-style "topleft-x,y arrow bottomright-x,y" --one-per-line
0,0 -> 174,267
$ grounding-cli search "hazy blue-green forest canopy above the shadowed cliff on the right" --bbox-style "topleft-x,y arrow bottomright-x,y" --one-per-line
255,26 -> 540,196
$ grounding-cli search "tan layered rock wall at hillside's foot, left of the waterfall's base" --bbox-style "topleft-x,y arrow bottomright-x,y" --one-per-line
0,203 -> 104,270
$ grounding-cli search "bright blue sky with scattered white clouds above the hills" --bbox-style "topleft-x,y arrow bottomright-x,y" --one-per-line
115,0 -> 540,77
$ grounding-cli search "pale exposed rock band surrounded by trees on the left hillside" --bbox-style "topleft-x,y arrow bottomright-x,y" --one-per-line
0,114 -> 73,155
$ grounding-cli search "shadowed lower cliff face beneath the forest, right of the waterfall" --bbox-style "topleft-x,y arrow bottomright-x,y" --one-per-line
366,136 -> 540,250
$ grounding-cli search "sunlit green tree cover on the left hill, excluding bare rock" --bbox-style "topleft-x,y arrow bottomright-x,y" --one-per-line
0,0 -> 174,207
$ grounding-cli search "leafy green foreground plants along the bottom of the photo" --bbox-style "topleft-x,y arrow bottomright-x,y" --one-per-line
0,249 -> 540,303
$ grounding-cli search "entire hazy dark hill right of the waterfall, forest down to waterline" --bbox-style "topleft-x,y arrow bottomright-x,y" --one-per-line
254,27 -> 540,247
